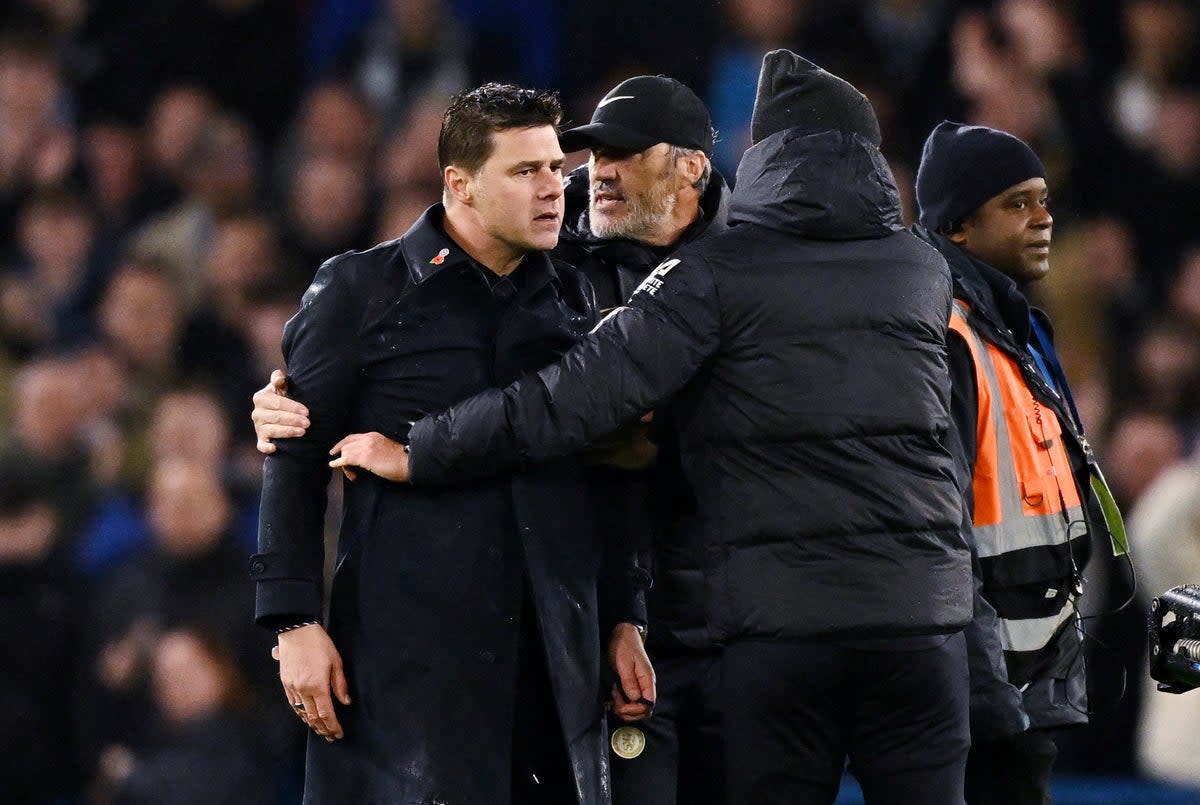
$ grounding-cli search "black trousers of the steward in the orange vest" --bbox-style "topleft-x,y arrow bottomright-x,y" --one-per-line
966,729 -> 1058,805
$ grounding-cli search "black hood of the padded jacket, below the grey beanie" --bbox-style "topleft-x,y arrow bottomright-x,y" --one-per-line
730,128 -> 904,240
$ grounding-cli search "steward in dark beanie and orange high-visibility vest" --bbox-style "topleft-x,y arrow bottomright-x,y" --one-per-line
916,121 -> 1123,805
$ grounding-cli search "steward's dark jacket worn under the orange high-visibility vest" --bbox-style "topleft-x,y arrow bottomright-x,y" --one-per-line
916,227 -> 1108,738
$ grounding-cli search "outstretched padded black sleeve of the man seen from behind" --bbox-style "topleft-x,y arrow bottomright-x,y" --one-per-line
406,256 -> 720,485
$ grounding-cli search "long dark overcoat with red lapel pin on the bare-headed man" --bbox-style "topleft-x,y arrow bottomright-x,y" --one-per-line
251,205 -> 608,805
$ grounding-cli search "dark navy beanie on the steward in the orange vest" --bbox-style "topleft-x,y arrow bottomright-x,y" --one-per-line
917,120 -> 1046,232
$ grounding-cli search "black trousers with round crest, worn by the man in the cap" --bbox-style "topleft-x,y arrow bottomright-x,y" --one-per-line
608,651 -> 725,805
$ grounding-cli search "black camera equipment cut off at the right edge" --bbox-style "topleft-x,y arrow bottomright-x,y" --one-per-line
1148,584 -> 1200,693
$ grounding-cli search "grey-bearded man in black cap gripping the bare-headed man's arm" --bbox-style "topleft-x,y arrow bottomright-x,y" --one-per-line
252,76 -> 730,805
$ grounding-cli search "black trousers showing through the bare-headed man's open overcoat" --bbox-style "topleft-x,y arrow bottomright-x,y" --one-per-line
512,588 -> 578,805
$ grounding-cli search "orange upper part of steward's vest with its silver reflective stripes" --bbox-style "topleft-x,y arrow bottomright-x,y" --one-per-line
950,299 -> 1086,558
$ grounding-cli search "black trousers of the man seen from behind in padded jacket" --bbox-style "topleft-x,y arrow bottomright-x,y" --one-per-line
721,633 -> 971,805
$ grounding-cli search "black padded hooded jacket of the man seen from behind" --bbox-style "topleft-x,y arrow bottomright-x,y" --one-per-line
410,130 -> 972,641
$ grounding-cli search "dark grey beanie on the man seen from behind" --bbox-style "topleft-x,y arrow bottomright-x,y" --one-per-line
750,49 -> 882,146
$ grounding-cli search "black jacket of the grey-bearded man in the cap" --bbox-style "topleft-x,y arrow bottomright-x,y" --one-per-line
553,166 -> 730,659
